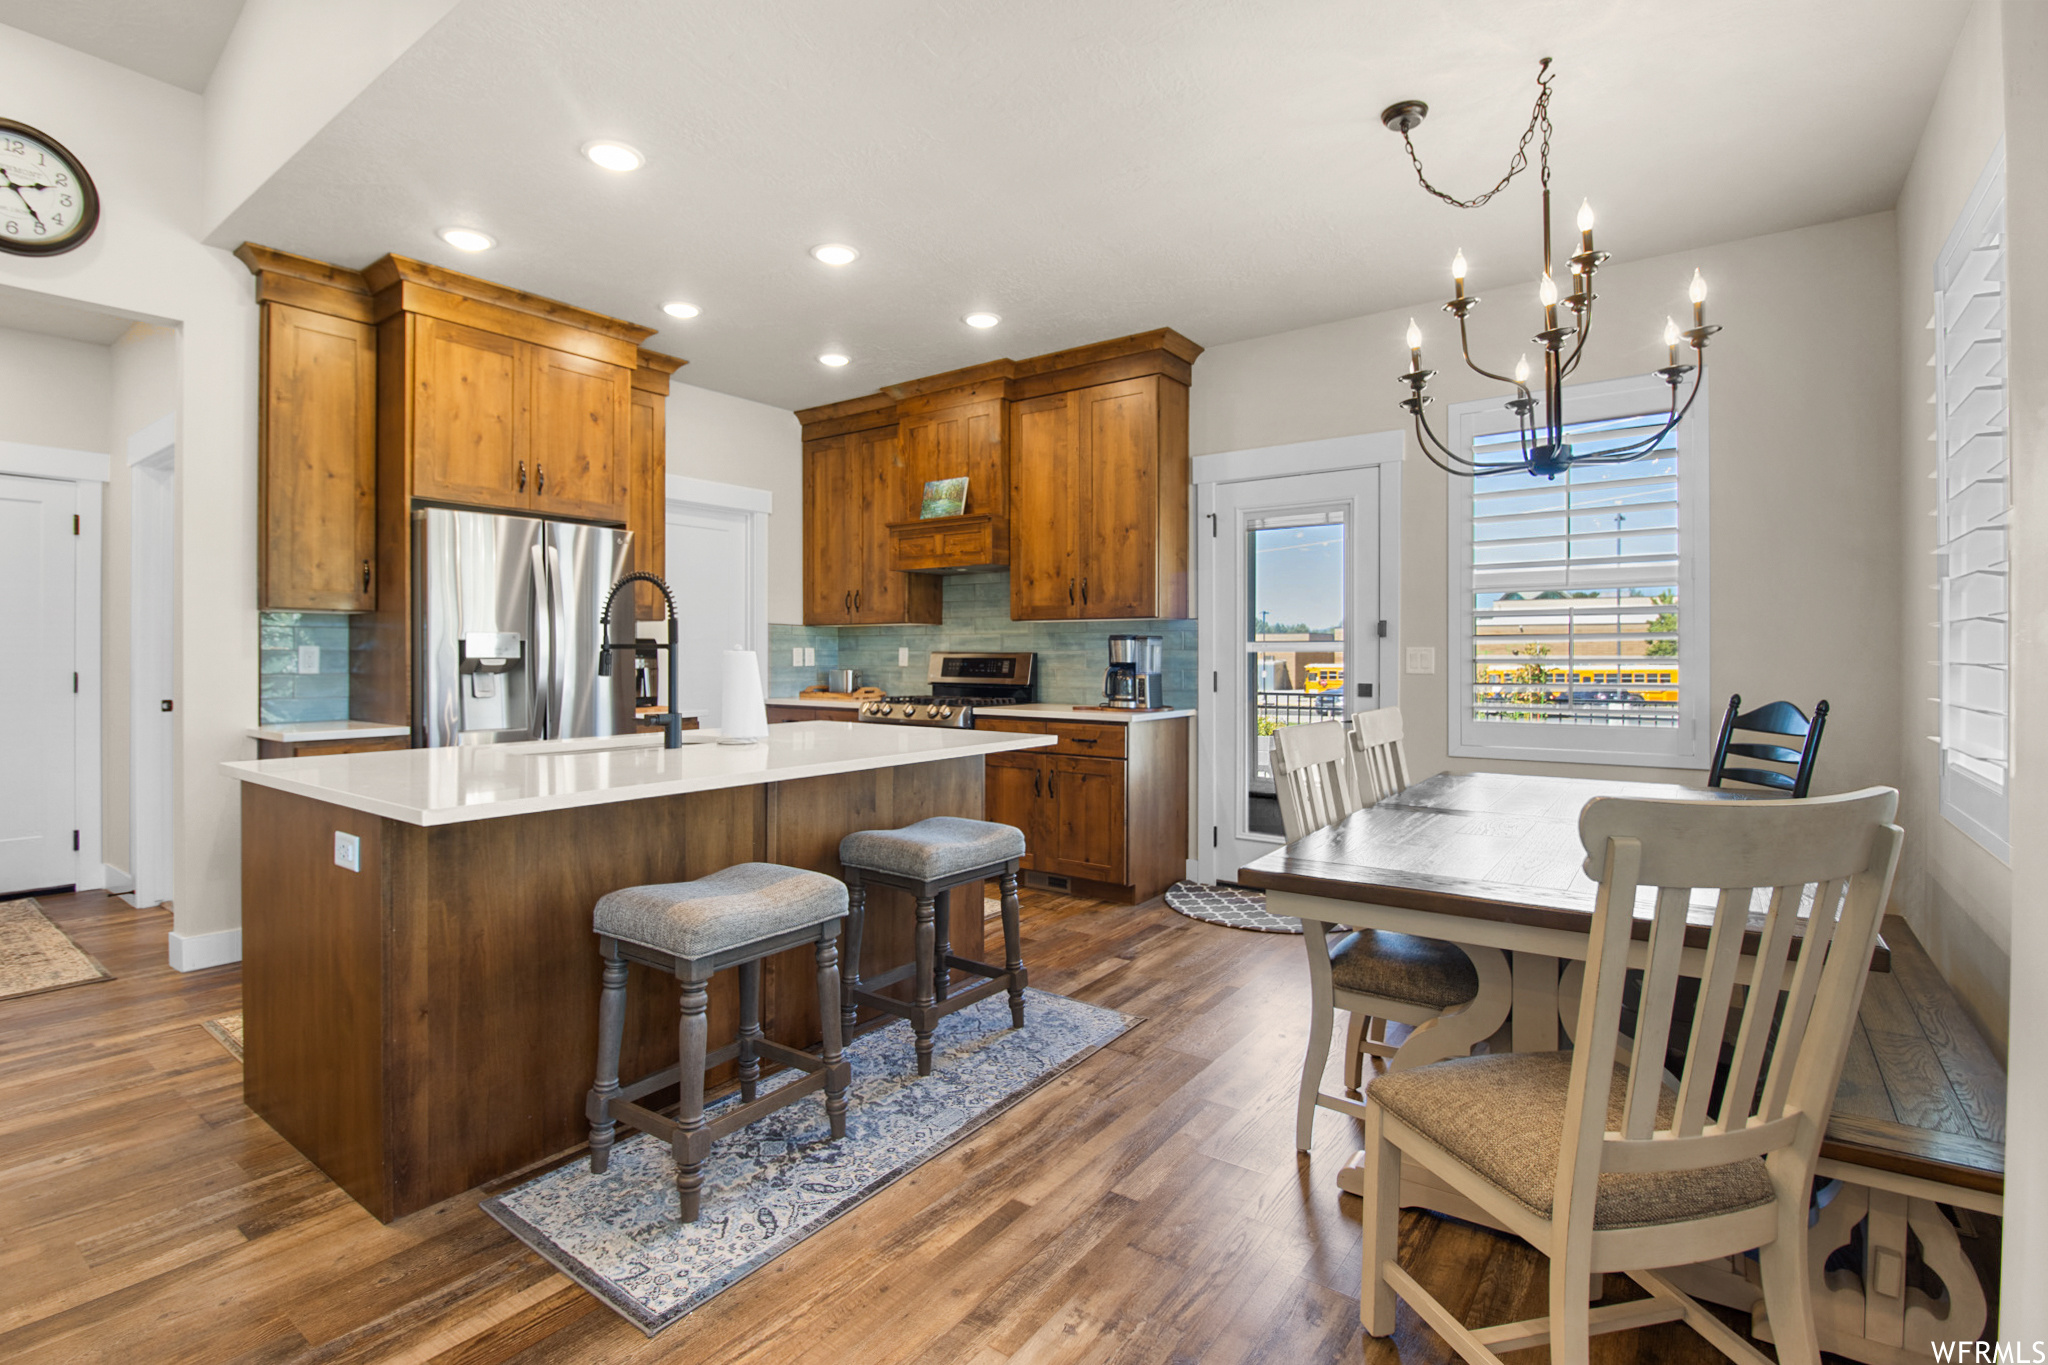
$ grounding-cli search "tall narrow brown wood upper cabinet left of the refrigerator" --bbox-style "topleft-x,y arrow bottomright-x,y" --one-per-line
256,303 -> 377,612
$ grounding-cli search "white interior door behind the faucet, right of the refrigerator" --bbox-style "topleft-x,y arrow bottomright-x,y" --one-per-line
667,501 -> 758,729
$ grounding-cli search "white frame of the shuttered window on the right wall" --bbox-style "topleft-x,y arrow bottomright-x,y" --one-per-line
1927,137 -> 2013,866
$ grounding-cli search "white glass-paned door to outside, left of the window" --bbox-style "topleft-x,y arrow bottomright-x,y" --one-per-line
1202,469 -> 1386,880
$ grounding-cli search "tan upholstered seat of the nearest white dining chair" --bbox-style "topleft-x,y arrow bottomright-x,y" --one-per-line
1366,1052 -> 1774,1230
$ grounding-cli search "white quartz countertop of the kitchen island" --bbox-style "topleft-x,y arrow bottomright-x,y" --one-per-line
221,720 -> 1053,825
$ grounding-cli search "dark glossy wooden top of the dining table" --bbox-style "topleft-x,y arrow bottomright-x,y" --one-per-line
1237,774 -> 1888,970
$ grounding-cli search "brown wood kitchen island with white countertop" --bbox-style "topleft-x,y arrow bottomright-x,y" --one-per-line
223,720 -> 1053,1222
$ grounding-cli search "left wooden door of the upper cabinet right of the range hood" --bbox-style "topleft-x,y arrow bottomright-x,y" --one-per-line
1010,393 -> 1083,620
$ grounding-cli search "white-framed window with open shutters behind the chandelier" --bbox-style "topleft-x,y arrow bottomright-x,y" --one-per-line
1450,377 -> 1718,767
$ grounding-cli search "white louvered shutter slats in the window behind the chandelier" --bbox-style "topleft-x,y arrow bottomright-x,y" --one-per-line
1464,411 -> 1688,729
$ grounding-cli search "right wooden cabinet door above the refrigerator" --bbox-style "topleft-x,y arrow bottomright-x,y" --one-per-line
522,346 -> 633,522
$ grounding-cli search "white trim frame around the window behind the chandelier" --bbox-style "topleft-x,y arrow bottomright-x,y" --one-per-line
1446,375 -> 1720,769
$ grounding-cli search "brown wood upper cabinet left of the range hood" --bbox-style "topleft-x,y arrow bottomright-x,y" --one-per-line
803,426 -> 940,626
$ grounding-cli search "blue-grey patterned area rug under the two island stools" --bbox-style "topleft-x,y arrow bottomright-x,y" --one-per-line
483,990 -> 1141,1336
